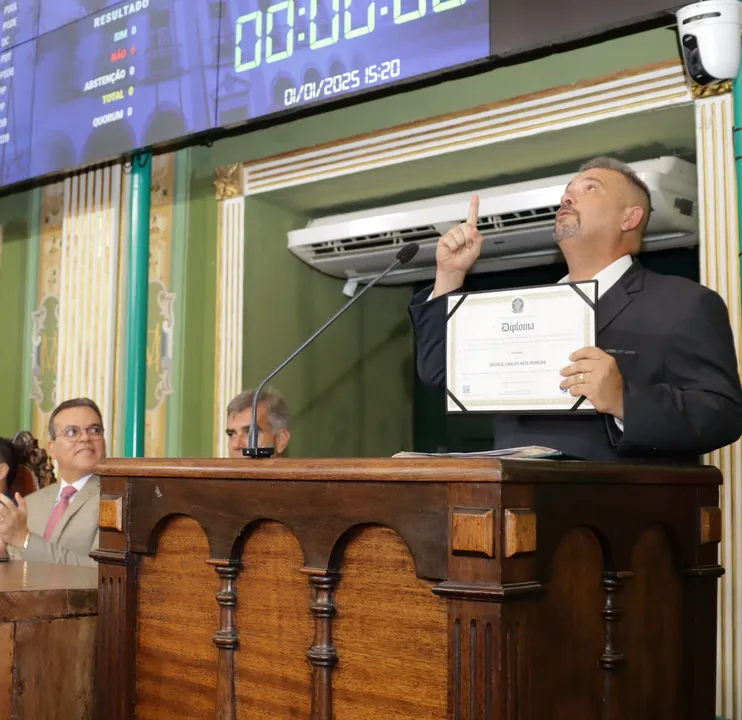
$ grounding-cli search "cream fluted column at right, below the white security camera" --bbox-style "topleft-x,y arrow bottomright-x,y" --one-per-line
688,82 -> 742,718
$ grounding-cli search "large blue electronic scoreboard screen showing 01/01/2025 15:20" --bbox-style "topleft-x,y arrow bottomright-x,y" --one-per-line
0,0 -> 490,187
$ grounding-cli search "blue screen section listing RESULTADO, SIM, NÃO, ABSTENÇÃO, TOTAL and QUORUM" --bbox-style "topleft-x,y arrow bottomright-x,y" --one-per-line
31,0 -> 219,176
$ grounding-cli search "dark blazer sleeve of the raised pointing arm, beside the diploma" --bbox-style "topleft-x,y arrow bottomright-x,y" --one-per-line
409,285 -> 447,388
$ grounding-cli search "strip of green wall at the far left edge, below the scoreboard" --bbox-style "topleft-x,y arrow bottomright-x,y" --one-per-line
0,193 -> 31,437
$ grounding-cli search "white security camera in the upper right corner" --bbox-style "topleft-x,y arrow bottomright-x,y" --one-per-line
675,0 -> 742,85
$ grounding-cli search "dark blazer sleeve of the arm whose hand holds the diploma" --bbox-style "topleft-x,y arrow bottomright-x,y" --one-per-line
618,291 -> 742,456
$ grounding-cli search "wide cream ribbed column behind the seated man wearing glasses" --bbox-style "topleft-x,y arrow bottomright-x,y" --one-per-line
53,165 -> 123,429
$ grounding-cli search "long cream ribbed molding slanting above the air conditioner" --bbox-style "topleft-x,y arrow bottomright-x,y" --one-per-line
241,61 -> 693,195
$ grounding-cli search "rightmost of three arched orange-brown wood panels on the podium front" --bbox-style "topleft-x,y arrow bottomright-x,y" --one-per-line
333,527 -> 448,720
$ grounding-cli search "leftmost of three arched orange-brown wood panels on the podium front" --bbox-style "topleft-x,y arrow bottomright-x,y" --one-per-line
136,517 -> 219,720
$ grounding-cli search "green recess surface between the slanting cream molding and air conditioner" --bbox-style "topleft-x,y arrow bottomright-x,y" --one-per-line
260,103 -> 695,217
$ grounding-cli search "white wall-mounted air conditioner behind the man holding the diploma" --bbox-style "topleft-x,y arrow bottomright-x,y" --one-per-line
289,157 -> 698,284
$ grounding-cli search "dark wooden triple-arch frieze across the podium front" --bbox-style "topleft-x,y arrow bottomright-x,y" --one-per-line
129,477 -> 448,579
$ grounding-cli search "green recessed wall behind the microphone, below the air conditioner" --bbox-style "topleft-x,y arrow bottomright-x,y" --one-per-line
238,198 -> 412,457
